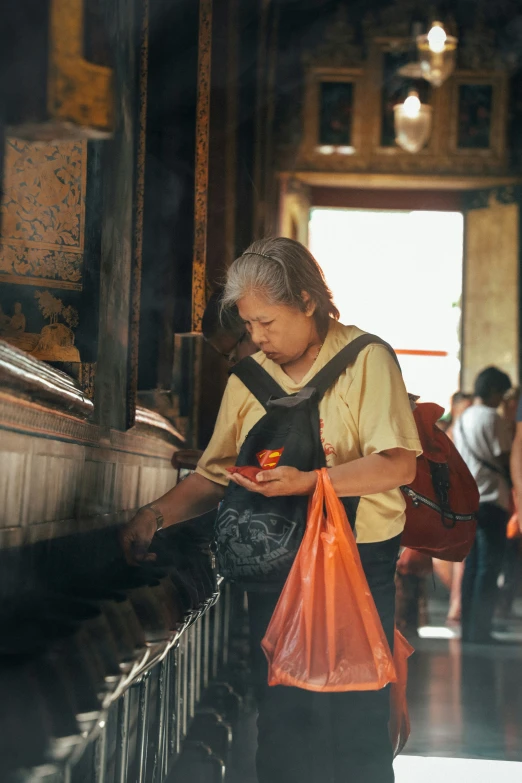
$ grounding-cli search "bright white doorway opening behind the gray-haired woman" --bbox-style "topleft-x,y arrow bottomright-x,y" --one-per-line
309,208 -> 464,408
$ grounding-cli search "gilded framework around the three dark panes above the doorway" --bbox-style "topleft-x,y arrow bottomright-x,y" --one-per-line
290,25 -> 509,181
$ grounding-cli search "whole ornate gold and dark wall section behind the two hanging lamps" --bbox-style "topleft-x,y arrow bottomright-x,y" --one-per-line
277,0 -> 511,181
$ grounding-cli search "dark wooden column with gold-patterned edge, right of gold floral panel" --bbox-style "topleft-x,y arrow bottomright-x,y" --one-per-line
95,0 -> 147,430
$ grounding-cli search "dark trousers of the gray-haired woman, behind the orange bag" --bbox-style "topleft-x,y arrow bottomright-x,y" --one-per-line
248,536 -> 400,783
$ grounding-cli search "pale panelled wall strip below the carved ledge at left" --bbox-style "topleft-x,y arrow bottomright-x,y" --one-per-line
0,429 -> 177,548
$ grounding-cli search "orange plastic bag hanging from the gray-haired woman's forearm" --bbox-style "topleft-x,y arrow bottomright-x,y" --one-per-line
262,469 -> 397,692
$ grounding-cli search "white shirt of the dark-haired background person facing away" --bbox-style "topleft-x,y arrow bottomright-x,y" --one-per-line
453,405 -> 512,511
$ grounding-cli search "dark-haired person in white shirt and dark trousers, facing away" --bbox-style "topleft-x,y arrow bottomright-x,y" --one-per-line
454,367 -> 511,643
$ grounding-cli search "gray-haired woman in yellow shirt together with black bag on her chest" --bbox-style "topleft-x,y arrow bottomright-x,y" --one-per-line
120,238 -> 421,783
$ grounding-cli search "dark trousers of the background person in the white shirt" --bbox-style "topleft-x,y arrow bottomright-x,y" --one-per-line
462,503 -> 509,642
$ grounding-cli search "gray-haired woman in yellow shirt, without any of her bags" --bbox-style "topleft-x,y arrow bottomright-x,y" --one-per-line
121,238 -> 421,783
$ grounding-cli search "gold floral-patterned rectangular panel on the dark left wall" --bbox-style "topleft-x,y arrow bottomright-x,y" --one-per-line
0,138 -> 87,291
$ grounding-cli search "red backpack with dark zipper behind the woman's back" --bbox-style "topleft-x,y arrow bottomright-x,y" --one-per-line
346,334 -> 479,561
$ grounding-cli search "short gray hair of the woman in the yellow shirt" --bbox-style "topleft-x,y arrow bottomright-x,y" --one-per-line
222,237 -> 339,331
